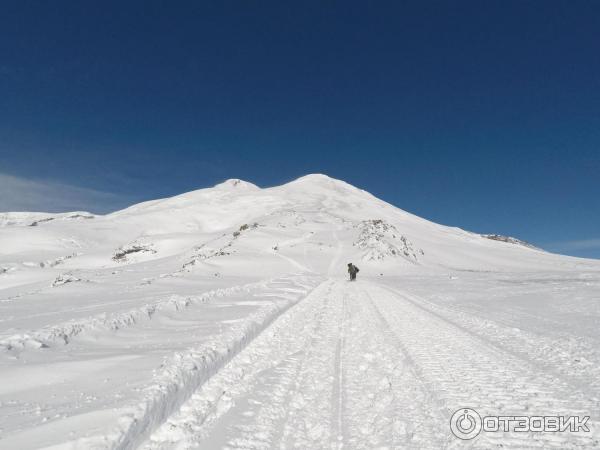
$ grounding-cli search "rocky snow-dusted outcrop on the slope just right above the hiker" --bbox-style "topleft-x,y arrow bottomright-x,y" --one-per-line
352,219 -> 425,263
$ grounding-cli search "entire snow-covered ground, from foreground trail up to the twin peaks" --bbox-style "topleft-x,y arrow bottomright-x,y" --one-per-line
0,175 -> 600,449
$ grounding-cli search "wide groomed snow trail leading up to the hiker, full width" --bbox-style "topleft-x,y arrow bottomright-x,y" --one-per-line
143,280 -> 598,449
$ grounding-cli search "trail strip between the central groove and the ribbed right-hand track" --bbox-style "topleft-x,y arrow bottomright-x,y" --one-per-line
346,283 -> 448,449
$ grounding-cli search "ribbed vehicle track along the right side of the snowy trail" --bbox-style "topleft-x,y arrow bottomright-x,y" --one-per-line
371,286 -> 598,448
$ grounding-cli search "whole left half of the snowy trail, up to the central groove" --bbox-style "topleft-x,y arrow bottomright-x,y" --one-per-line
146,282 -> 343,449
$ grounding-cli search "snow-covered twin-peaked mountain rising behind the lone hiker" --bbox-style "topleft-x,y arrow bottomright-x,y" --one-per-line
0,175 -> 590,283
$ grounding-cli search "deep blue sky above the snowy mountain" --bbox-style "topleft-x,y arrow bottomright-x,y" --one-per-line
0,0 -> 600,257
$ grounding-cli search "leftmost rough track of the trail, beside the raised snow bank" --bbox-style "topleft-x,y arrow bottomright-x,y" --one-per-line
144,282 -> 330,449
